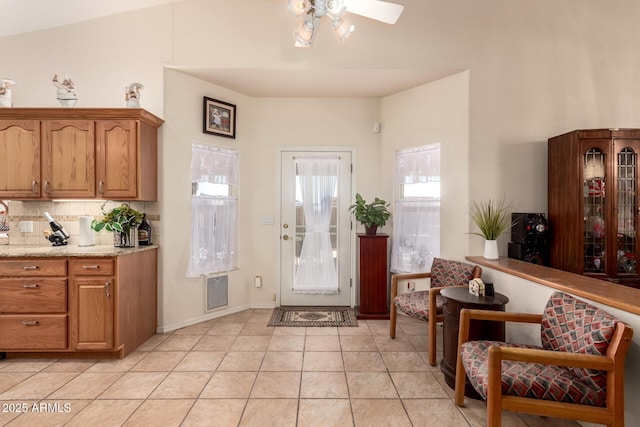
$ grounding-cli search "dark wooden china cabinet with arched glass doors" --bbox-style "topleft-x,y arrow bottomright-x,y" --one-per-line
548,129 -> 640,287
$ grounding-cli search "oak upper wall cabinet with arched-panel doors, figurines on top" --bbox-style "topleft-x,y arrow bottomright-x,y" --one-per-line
0,108 -> 163,201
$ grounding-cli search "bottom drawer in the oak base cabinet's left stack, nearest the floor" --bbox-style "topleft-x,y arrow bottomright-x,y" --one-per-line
0,314 -> 67,351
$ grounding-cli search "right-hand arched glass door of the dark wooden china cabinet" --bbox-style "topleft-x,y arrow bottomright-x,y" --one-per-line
616,146 -> 638,275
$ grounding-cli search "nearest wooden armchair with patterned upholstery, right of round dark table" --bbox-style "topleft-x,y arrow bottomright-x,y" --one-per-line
455,292 -> 633,427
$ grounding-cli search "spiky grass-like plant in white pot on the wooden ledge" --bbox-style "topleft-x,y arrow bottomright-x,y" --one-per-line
471,199 -> 512,259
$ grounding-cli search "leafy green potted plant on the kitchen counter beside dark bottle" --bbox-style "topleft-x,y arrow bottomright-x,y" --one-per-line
91,202 -> 143,248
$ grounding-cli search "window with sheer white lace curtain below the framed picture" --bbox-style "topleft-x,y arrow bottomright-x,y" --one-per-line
187,143 -> 238,277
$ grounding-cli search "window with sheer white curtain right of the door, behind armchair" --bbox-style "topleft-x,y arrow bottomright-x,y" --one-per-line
391,144 -> 440,273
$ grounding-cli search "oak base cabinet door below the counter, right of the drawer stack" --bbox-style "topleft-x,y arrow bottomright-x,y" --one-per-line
72,277 -> 114,350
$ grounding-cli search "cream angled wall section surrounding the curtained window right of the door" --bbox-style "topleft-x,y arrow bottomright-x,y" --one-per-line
380,71 -> 470,260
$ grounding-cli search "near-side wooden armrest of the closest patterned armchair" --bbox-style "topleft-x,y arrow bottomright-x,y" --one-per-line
489,346 -> 615,371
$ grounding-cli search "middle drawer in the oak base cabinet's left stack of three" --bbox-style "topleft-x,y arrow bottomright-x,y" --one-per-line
0,278 -> 67,313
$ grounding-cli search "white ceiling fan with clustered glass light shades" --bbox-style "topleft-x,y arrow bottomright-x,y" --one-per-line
289,0 -> 404,47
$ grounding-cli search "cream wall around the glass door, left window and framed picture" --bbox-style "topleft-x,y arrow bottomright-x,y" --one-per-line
160,70 -> 380,330
